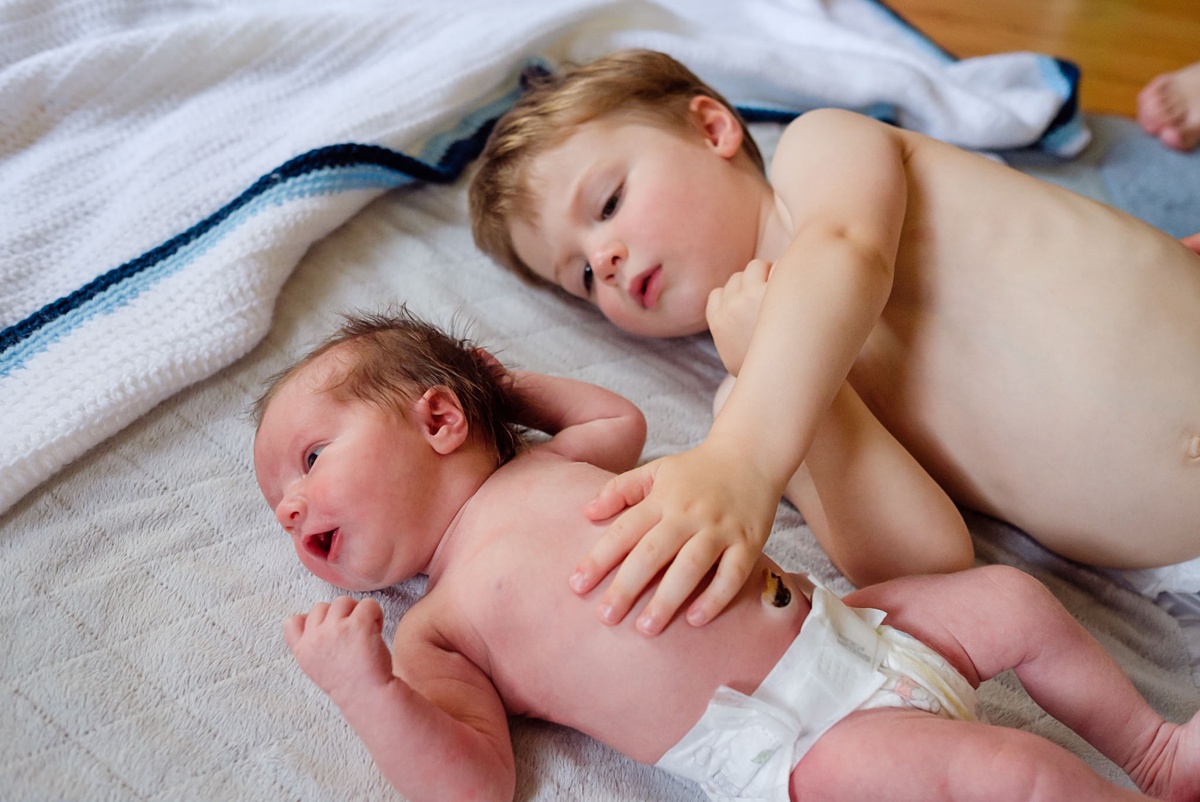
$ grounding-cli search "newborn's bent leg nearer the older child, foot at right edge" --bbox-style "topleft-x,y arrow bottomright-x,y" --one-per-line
846,565 -> 1200,800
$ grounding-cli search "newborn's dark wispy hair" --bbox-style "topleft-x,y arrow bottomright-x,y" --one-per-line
251,306 -> 524,466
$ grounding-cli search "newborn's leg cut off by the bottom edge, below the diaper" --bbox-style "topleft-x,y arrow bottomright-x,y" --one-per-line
791,708 -> 1146,802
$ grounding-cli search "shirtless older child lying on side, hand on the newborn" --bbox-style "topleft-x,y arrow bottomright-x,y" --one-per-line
470,50 -> 1200,634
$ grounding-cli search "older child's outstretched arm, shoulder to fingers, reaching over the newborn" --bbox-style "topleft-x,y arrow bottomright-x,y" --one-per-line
576,109 -> 907,634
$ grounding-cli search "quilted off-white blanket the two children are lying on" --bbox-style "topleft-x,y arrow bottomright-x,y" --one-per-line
0,115 -> 1200,802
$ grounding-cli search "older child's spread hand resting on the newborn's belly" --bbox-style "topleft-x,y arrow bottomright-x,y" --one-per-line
571,439 -> 779,635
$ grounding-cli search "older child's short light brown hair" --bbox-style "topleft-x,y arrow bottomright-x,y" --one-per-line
468,50 -> 766,285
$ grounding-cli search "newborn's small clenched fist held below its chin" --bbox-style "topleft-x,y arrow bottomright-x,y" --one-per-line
283,595 -> 392,707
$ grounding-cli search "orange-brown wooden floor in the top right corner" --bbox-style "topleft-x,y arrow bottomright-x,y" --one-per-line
884,0 -> 1200,116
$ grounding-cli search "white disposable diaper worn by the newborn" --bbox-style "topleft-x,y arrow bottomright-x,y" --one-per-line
655,578 -> 983,802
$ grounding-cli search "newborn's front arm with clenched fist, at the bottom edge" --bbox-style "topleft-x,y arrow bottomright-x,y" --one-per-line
283,597 -> 516,802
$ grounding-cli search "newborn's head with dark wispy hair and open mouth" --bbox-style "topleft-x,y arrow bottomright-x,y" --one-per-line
253,309 -> 522,591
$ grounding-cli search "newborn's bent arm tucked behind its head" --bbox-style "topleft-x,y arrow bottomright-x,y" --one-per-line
509,371 -> 646,473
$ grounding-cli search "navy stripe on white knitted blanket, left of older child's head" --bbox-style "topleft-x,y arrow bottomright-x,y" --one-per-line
0,118 -> 496,353
